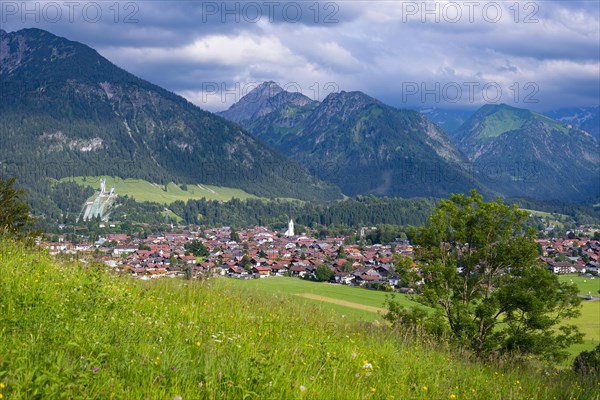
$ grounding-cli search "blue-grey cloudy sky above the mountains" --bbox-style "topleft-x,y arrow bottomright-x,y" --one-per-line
0,0 -> 600,111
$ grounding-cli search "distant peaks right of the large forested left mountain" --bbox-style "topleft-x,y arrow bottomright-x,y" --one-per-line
219,82 -> 600,201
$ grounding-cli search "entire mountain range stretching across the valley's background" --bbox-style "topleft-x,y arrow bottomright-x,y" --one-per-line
0,29 -> 600,219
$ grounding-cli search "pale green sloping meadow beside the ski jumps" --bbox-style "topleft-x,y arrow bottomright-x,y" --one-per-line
61,176 -> 257,204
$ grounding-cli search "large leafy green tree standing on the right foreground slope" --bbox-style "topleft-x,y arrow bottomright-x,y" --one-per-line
390,190 -> 582,360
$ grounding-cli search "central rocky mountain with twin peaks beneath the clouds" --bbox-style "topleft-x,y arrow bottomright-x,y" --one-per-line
220,82 -> 492,197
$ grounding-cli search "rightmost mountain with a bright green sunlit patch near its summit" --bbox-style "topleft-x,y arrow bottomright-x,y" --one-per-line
455,104 -> 600,201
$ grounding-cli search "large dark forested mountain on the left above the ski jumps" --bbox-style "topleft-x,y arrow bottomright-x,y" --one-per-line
0,29 -> 341,219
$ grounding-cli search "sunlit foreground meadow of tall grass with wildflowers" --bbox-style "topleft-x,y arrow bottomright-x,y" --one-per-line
0,241 -> 598,399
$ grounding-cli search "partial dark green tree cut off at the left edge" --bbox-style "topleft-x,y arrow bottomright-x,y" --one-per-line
0,177 -> 39,239
